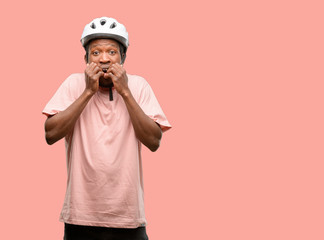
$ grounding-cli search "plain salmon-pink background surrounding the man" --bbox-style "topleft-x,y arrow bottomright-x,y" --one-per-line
0,0 -> 324,240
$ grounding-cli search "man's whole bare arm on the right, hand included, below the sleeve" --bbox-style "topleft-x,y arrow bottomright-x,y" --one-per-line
109,63 -> 162,152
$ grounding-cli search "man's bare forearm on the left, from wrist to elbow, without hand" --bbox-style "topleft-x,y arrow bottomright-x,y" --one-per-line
45,90 -> 93,145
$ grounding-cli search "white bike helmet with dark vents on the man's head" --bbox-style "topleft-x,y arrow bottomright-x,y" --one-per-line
81,17 -> 129,53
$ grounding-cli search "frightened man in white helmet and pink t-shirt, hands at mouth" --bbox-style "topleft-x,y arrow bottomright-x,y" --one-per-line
43,17 -> 171,240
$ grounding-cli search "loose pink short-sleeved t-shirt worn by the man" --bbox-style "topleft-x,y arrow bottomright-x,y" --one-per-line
43,73 -> 171,228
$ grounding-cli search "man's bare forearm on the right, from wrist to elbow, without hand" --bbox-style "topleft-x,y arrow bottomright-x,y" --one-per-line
122,91 -> 162,152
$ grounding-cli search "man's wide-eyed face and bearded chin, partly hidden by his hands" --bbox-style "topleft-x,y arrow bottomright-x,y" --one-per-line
86,39 -> 121,88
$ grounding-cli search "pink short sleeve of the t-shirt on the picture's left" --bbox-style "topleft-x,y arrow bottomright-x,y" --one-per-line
42,75 -> 82,116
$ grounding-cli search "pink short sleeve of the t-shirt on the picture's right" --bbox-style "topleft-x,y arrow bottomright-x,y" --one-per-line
139,82 -> 171,132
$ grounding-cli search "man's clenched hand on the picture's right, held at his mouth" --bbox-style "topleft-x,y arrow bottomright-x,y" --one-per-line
107,63 -> 129,96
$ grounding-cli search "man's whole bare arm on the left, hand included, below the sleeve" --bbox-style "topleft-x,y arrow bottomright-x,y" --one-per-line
45,64 -> 103,144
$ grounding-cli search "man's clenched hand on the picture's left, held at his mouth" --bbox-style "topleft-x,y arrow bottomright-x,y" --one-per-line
84,62 -> 104,94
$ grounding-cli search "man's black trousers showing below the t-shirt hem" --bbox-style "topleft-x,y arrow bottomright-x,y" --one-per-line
64,223 -> 148,240
